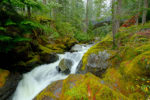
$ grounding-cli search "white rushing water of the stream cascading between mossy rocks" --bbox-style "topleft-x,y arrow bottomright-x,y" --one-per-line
12,45 -> 91,100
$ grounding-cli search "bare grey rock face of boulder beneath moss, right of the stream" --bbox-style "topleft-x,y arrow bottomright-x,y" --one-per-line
77,51 -> 110,77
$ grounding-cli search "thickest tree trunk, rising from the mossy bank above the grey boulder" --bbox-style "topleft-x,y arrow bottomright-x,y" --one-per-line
112,0 -> 122,46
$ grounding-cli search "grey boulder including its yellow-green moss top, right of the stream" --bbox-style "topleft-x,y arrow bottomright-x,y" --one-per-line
78,35 -> 116,77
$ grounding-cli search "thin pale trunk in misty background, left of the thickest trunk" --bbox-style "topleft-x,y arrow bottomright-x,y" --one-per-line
84,0 -> 89,33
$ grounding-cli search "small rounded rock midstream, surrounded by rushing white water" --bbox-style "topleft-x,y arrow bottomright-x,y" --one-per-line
57,59 -> 73,74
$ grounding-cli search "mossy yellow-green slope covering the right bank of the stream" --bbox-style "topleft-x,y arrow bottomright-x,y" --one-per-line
82,23 -> 150,100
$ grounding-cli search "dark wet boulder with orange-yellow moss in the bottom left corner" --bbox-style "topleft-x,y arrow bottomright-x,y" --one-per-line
0,69 -> 22,100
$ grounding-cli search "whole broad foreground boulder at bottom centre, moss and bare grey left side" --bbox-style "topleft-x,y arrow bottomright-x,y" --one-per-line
34,73 -> 128,100
